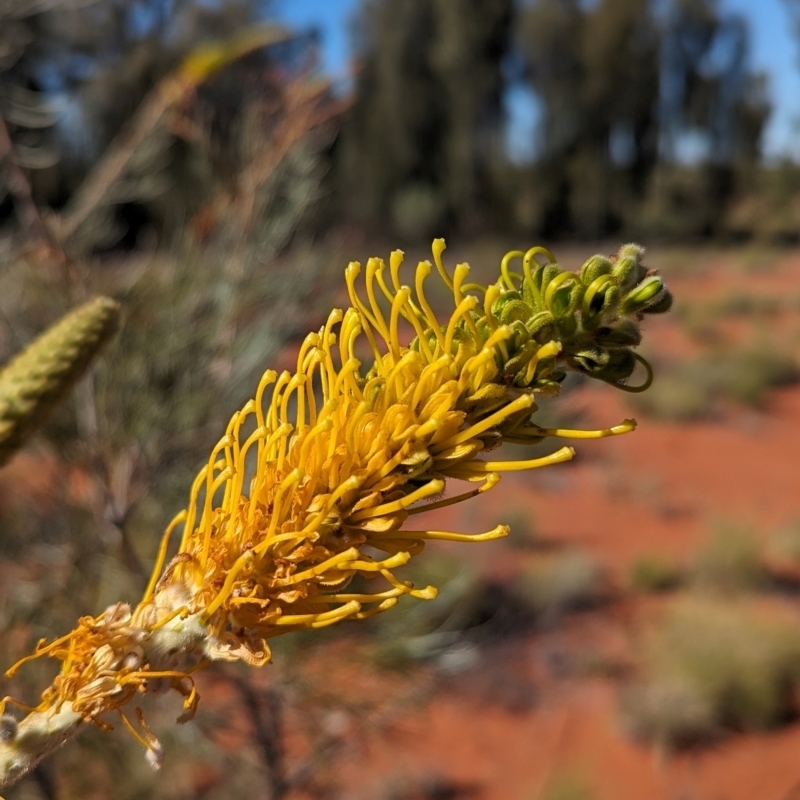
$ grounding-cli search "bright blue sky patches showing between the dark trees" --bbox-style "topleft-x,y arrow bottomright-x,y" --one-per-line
276,0 -> 800,160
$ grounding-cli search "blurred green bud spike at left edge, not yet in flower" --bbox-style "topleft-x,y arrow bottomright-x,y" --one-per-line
0,297 -> 119,464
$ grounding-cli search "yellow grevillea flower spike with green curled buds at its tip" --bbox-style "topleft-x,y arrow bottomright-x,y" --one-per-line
0,239 -> 671,785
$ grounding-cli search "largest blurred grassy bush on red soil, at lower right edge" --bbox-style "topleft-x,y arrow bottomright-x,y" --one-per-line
622,598 -> 800,747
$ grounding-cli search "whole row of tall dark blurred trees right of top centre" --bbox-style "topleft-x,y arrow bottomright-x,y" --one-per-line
333,0 -> 776,239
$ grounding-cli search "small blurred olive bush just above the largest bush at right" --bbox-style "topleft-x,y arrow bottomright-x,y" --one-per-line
690,523 -> 768,594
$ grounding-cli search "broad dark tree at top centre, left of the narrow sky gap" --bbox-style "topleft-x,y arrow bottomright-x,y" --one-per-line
336,0 -> 512,238
